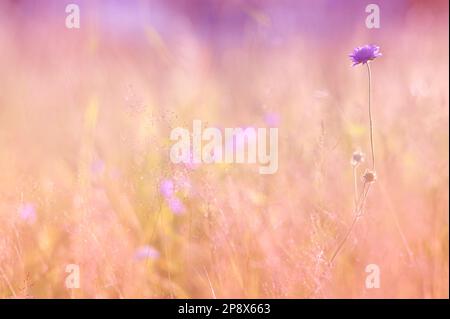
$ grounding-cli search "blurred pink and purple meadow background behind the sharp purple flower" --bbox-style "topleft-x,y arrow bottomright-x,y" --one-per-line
0,0 -> 449,298
